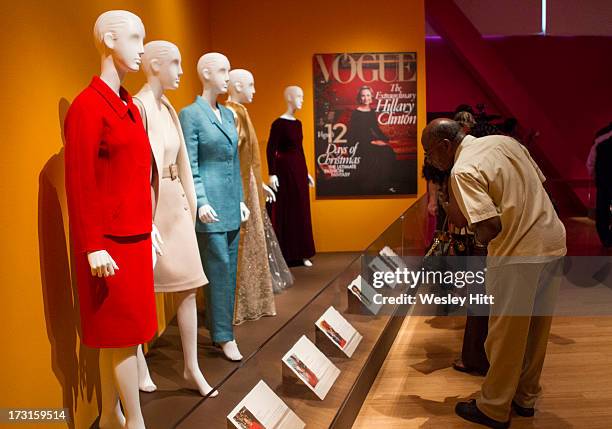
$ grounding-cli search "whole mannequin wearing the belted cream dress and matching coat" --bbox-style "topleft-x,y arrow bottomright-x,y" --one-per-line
134,41 -> 217,396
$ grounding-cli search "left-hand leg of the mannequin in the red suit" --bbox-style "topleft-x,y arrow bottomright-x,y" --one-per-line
98,349 -> 125,429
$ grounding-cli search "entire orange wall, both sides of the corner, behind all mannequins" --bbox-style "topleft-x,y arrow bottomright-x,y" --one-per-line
0,0 -> 425,428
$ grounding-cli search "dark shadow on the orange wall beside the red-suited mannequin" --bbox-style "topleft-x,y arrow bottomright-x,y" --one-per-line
38,98 -> 100,429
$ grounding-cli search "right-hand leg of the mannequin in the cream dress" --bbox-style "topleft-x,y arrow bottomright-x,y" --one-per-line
176,289 -> 219,397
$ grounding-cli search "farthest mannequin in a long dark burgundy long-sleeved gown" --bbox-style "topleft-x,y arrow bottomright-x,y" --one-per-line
266,86 -> 315,267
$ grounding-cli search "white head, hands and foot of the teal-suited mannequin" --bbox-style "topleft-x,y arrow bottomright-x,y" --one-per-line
197,52 -> 245,361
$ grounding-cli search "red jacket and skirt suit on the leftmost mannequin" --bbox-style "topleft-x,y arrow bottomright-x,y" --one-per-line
64,77 -> 157,347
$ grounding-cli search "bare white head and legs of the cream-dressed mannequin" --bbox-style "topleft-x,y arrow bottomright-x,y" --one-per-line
138,41 -> 218,397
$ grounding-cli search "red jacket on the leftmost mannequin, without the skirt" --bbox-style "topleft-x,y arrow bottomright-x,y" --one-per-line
64,76 -> 152,252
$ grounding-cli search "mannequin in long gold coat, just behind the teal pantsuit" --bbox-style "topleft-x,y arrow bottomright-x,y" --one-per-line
225,69 -> 276,325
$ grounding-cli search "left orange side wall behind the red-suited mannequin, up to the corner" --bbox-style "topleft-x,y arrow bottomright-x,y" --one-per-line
0,0 -> 209,428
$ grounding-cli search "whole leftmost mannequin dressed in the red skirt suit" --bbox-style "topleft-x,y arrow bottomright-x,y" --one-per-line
64,10 -> 161,429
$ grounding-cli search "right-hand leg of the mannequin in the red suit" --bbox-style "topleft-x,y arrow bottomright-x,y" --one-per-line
112,346 -> 145,429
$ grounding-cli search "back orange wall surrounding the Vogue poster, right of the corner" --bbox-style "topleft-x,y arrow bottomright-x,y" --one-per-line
210,0 -> 426,251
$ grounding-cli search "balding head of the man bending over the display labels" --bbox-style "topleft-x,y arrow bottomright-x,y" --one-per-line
421,118 -> 465,171
